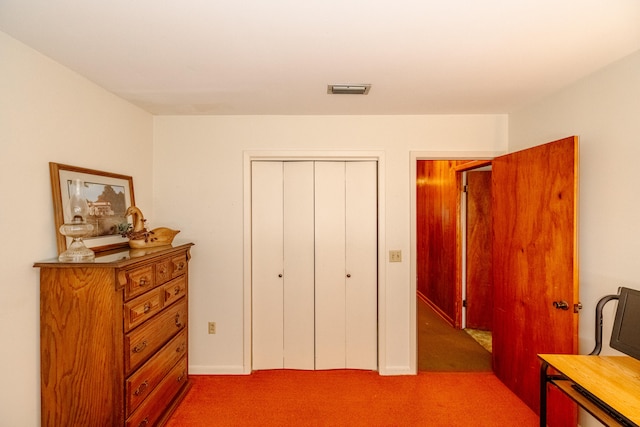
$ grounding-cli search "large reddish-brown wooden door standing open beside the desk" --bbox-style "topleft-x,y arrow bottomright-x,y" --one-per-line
492,137 -> 579,427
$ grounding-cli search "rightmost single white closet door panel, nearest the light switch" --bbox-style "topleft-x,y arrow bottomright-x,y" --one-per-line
345,162 -> 378,370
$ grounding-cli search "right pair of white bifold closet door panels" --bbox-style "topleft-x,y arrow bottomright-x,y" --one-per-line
315,162 -> 377,369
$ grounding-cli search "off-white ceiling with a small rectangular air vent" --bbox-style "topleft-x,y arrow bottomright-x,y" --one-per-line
0,0 -> 640,115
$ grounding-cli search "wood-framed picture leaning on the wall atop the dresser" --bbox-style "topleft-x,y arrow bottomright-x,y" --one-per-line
49,162 -> 135,254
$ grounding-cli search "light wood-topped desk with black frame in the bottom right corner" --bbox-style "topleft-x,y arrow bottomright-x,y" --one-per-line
538,354 -> 640,426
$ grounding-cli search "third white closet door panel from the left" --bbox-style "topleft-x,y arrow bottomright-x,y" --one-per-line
315,162 -> 346,369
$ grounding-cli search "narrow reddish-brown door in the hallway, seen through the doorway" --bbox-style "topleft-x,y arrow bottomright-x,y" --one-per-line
466,171 -> 493,331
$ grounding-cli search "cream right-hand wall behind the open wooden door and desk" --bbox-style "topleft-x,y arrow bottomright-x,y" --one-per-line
509,47 -> 640,426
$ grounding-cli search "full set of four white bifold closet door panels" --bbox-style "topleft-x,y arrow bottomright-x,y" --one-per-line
252,162 -> 377,369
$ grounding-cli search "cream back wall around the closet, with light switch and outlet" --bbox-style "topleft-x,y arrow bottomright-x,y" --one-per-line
154,115 -> 507,373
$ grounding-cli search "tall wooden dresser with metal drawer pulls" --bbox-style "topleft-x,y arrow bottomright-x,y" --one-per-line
35,243 -> 192,427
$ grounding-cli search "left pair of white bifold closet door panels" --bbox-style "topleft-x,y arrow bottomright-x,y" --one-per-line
251,161 -> 314,369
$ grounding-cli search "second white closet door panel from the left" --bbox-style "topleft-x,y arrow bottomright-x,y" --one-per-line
284,162 -> 315,369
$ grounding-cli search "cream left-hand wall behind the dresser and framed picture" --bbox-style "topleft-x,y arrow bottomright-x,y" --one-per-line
0,32 -> 153,427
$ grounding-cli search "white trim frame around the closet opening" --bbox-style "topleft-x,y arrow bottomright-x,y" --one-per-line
243,150 -> 384,375
